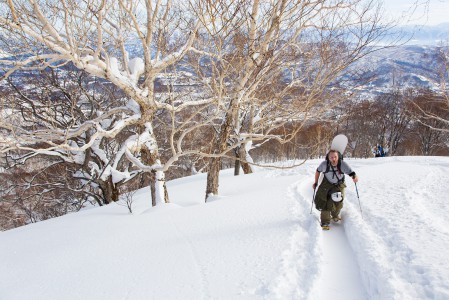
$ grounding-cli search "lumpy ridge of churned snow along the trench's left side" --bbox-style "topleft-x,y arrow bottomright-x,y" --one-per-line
265,182 -> 321,300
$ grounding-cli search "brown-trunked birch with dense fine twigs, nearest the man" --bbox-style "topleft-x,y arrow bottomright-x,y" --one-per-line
193,0 -> 388,202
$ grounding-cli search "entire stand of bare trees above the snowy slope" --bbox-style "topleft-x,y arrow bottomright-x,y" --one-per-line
0,0 -> 449,229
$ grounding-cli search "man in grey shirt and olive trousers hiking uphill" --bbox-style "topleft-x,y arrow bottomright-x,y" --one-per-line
313,150 -> 358,230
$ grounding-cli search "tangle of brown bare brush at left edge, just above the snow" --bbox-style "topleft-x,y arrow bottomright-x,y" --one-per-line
0,160 -> 88,227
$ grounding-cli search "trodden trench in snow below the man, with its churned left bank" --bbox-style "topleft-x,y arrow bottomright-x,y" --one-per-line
270,176 -> 366,300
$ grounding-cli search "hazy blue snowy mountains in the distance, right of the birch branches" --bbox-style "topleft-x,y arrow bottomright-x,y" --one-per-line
0,23 -> 449,97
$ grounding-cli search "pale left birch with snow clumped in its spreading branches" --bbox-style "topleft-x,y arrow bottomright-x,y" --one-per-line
0,0 -> 202,204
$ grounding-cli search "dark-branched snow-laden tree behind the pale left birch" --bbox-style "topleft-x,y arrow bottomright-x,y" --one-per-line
0,68 -> 141,205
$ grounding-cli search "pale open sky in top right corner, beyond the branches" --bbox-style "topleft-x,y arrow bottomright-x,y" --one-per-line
383,0 -> 449,25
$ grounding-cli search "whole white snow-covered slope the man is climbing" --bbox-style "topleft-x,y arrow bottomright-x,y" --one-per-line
0,157 -> 449,300
